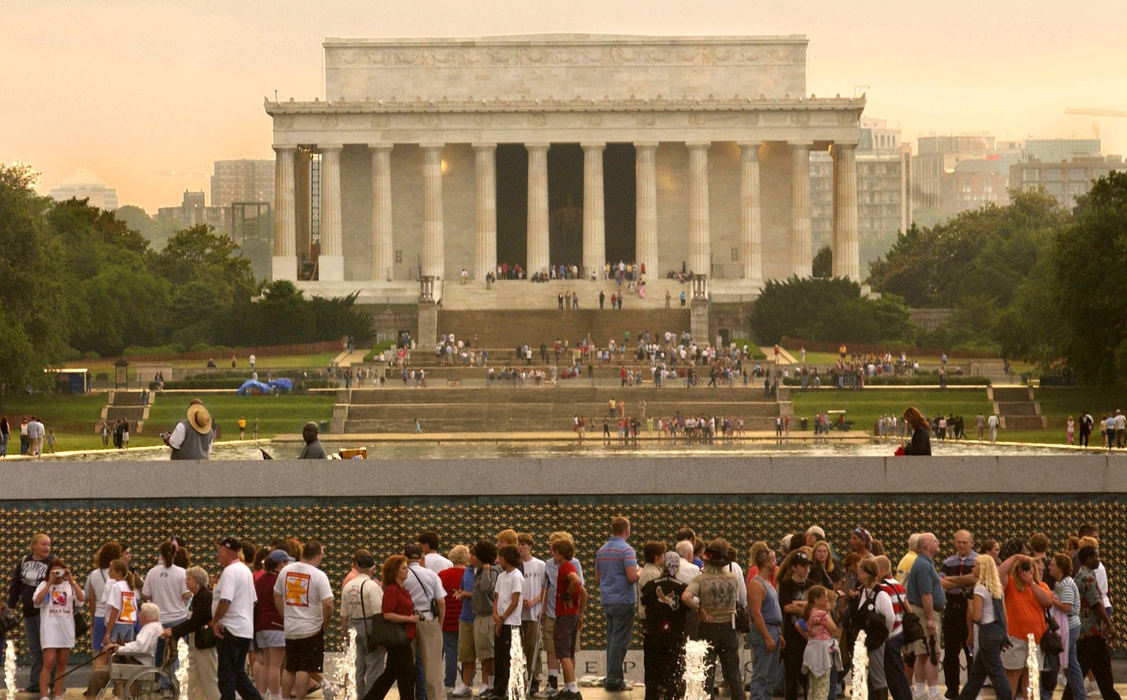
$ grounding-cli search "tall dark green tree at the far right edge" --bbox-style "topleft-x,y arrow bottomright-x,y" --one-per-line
1050,171 -> 1127,384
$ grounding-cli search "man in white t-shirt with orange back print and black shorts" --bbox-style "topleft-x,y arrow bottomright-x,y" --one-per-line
274,540 -> 332,700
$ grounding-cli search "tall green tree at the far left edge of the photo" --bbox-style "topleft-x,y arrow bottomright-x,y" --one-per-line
0,163 -> 66,389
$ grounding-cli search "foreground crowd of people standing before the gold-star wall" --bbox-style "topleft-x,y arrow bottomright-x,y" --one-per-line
0,516 -> 1119,700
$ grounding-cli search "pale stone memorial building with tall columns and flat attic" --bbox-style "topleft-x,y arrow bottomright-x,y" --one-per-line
265,35 -> 864,291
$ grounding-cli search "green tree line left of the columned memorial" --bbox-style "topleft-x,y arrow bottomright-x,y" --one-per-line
0,165 -> 371,387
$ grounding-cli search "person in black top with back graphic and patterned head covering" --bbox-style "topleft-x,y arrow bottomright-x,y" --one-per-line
641,551 -> 686,700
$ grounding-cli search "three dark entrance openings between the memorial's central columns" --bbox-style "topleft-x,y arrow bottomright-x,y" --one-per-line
497,143 -> 637,276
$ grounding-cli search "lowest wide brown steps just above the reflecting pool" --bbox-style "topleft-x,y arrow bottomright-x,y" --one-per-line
332,381 -> 792,433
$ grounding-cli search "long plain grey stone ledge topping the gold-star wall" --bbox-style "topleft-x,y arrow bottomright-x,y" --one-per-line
0,454 -> 1127,502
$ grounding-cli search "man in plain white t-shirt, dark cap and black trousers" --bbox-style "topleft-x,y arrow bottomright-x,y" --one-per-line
211,537 -> 263,700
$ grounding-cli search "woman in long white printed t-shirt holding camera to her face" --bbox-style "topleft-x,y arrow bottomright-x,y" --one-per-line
32,559 -> 86,698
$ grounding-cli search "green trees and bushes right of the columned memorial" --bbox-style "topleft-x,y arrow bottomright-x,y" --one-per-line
752,171 -> 1127,384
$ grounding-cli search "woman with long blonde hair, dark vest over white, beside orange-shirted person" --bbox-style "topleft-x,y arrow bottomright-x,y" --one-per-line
958,557 -> 1013,700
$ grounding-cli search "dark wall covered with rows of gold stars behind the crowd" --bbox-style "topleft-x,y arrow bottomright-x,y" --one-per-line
0,489 -> 1127,653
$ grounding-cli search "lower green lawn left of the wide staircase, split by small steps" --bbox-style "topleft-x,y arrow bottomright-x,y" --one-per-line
0,392 -> 336,451
